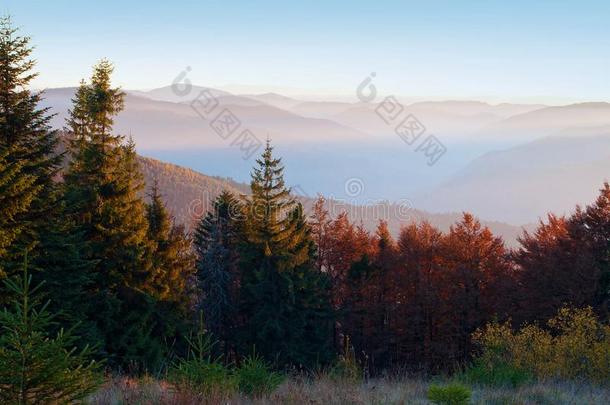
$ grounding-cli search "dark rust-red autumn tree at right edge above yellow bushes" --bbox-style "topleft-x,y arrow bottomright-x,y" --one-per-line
514,183 -> 610,321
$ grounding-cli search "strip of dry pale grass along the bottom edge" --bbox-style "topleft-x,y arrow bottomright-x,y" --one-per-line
89,376 -> 610,405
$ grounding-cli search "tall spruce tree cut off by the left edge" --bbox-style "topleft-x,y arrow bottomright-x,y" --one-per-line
0,18 -> 91,332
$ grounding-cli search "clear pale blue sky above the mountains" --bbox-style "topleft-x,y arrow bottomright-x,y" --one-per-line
0,0 -> 610,104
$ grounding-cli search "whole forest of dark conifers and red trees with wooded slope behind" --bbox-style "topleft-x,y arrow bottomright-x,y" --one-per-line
0,14 -> 610,405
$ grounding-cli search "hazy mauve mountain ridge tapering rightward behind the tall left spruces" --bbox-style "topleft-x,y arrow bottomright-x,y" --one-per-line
42,88 -> 369,151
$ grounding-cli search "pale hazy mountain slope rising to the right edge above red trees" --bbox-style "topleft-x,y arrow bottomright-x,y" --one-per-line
416,128 -> 610,223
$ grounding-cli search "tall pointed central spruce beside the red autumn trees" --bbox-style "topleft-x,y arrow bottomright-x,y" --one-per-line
239,142 -> 332,367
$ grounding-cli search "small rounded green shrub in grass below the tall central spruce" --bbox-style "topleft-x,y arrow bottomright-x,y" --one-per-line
235,355 -> 284,397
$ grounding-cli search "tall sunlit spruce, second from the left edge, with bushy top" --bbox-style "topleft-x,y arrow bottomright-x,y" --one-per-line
65,60 -> 163,367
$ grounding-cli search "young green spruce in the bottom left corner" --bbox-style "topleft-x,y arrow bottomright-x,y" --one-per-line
0,258 -> 101,405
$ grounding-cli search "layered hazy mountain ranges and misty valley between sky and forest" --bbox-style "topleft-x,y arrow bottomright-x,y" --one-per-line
42,85 -> 610,233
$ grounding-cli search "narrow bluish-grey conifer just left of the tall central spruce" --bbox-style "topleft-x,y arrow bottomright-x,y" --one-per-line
194,191 -> 241,352
